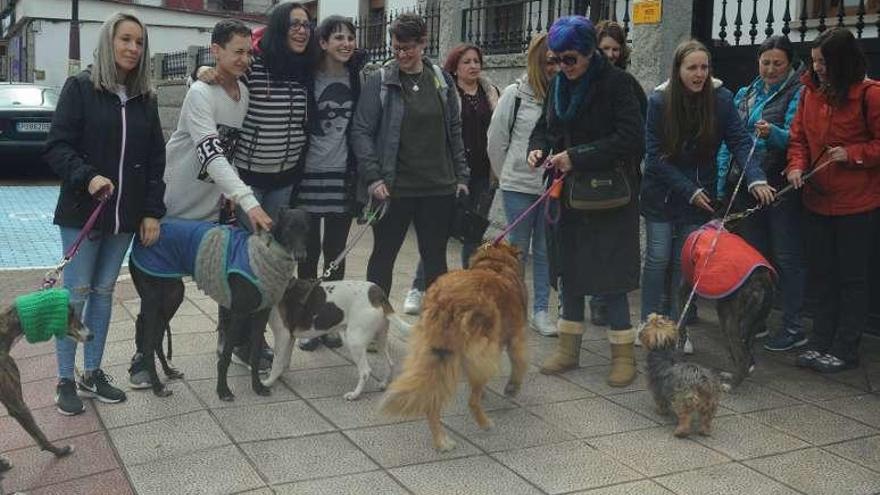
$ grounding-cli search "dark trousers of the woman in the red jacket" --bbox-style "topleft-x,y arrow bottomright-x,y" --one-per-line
804,210 -> 877,362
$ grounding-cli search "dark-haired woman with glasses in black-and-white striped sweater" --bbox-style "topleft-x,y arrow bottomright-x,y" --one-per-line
197,2 -> 317,370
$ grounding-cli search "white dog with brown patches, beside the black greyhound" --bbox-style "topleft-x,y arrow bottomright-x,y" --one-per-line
263,279 -> 394,400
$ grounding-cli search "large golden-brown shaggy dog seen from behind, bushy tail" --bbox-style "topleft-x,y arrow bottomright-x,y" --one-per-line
382,243 -> 528,451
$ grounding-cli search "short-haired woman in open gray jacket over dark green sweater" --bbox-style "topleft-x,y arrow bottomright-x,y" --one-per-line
351,14 -> 469,310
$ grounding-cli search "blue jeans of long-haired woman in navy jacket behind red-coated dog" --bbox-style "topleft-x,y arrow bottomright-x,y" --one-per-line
644,220 -> 700,321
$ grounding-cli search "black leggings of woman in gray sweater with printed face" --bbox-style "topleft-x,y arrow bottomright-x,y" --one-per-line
296,213 -> 351,280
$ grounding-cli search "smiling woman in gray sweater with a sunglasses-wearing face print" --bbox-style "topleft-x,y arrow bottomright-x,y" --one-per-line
291,15 -> 366,351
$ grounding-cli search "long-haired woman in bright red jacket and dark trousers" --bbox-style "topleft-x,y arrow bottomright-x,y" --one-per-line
786,29 -> 880,373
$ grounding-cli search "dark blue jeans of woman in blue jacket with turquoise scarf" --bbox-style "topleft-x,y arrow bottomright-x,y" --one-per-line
740,196 -> 807,333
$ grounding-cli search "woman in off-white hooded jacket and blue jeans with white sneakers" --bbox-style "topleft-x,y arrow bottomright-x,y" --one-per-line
488,34 -> 558,336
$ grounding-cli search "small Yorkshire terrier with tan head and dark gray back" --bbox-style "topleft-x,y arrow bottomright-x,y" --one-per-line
639,313 -> 723,437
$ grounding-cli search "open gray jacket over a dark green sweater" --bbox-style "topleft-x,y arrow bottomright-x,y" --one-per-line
350,59 -> 470,202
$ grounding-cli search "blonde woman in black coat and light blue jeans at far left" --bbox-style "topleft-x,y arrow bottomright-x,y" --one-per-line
44,13 -> 165,415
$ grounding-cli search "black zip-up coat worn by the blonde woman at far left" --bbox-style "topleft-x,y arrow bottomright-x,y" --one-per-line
43,70 -> 165,233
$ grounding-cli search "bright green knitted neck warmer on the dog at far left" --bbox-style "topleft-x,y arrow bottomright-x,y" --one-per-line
15,289 -> 70,344
